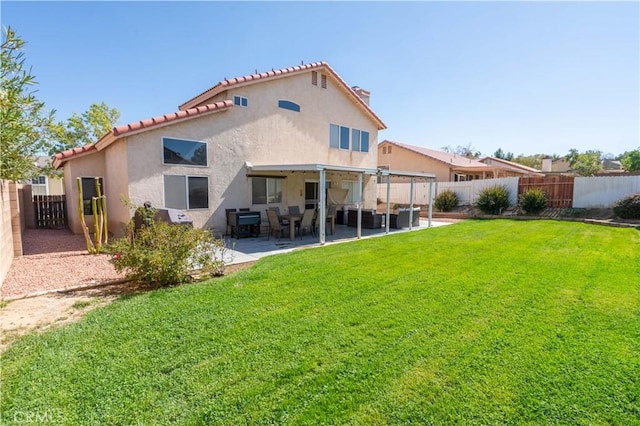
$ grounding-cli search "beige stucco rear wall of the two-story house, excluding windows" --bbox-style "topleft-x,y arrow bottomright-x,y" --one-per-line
122,74 -> 378,235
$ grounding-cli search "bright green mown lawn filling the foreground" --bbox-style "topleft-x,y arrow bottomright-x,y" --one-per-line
2,220 -> 640,425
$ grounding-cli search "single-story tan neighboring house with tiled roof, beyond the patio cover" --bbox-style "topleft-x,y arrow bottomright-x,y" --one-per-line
378,140 -> 496,182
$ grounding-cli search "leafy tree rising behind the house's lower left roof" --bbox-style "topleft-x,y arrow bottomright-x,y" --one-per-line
50,102 -> 120,155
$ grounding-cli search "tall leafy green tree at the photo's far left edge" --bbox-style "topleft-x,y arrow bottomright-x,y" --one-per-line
0,27 -> 54,181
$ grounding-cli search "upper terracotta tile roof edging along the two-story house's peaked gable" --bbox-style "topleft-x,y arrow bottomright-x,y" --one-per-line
178,61 -> 387,130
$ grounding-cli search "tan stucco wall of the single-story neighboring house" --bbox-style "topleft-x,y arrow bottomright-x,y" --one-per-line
378,143 -> 453,182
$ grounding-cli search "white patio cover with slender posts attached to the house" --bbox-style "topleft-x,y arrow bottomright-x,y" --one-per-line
246,162 -> 436,244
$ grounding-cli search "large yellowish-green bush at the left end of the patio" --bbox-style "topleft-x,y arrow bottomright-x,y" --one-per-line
107,216 -> 226,286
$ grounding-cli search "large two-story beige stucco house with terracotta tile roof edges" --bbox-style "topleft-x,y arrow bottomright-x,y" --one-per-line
54,62 -> 386,240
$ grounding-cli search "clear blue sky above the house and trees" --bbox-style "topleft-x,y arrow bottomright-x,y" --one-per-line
0,1 -> 640,155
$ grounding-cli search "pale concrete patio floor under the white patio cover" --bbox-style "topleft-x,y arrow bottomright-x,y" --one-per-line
224,219 -> 452,265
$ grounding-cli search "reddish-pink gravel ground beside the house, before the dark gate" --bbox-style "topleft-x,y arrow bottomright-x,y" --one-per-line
0,229 -> 123,299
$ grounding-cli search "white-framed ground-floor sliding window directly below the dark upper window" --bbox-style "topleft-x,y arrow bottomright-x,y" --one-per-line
164,175 -> 209,210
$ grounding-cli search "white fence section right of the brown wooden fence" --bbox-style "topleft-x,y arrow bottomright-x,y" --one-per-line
573,176 -> 640,208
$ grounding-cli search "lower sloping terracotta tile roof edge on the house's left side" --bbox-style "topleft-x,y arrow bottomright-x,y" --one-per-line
53,100 -> 233,168
